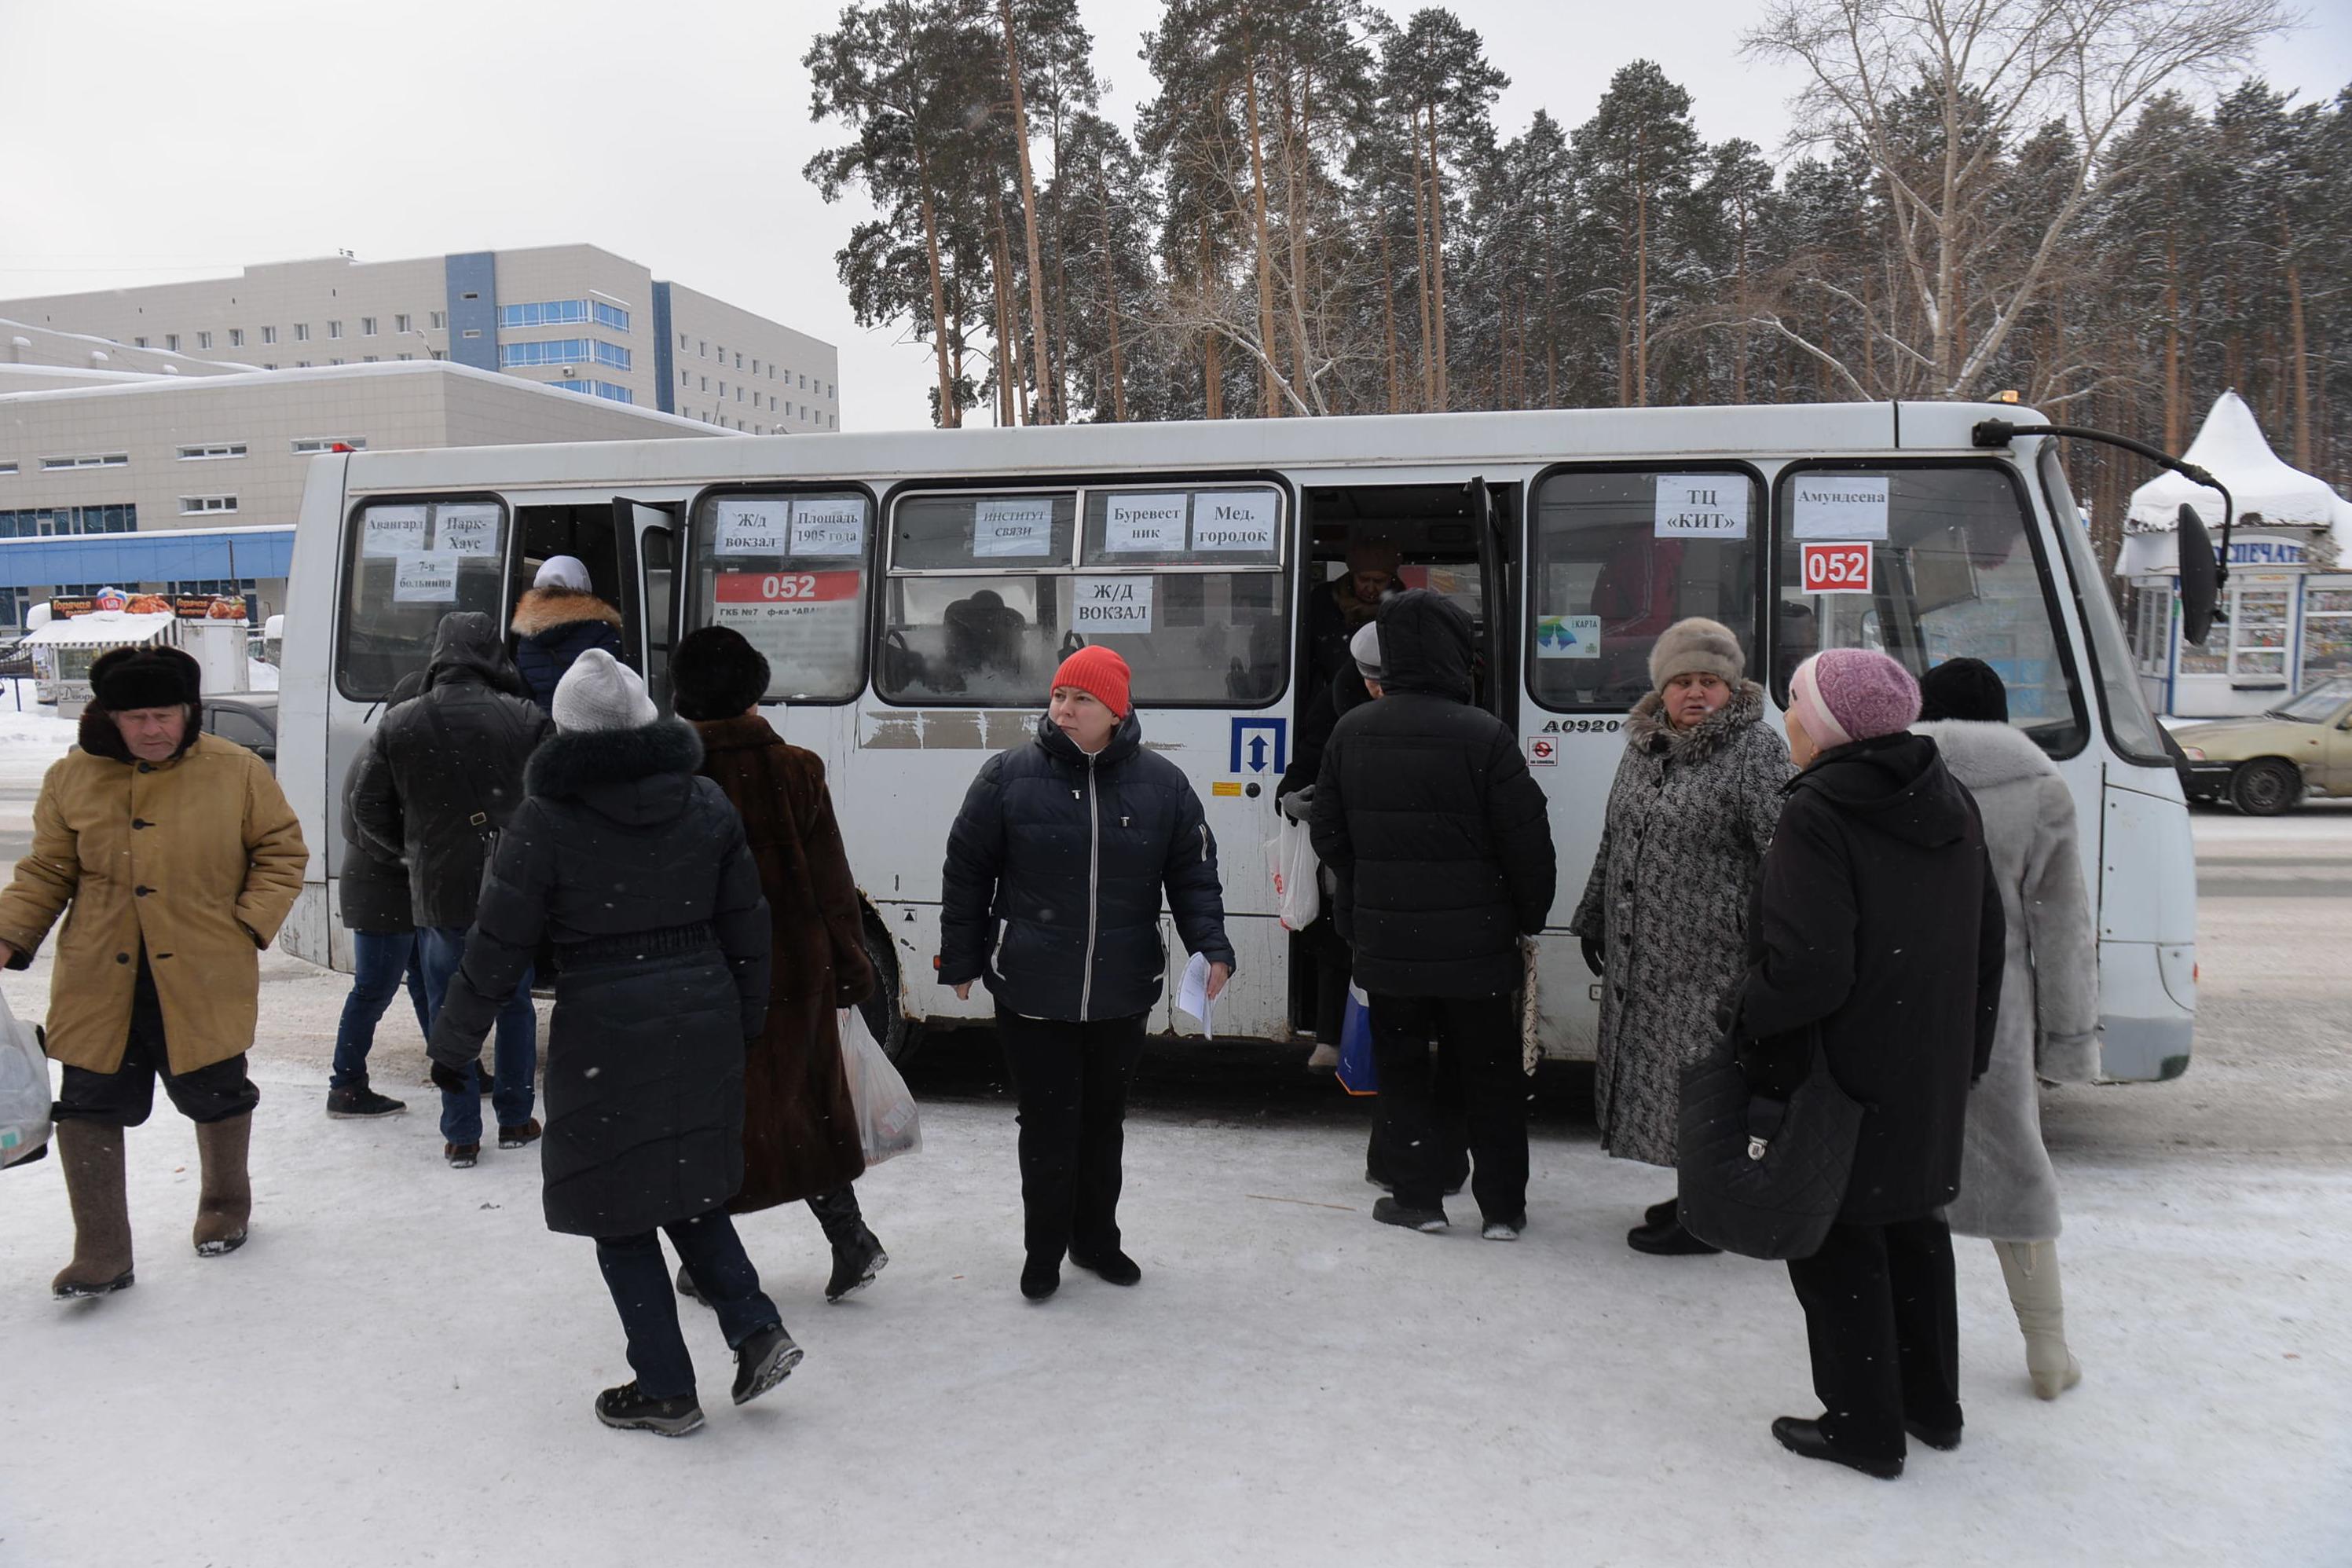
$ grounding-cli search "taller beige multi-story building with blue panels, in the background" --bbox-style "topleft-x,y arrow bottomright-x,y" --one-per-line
0,244 -> 842,435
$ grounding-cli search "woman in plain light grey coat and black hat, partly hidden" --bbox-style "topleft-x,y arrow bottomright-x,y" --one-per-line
1917,658 -> 2098,1399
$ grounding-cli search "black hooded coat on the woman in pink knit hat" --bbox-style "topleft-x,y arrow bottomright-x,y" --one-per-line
1736,734 -> 2006,1225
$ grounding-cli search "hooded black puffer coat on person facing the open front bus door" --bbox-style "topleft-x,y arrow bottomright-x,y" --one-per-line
1313,588 -> 1557,997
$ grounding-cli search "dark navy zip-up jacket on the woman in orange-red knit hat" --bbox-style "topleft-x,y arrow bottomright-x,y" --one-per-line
939,713 -> 1233,1020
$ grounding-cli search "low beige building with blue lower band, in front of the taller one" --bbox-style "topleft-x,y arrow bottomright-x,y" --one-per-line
0,354 -> 731,637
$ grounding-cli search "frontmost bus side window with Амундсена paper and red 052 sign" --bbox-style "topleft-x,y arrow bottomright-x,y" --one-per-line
1773,463 -> 2091,757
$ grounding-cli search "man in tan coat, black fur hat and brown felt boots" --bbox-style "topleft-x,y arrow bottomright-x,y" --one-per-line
0,649 -> 308,1298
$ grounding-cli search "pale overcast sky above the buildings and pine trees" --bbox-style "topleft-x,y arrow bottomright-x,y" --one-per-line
0,0 -> 2352,430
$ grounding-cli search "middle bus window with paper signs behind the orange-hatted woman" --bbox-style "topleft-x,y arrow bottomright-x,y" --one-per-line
875,486 -> 1289,708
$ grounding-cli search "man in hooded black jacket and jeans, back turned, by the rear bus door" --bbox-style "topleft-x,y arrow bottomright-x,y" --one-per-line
350,611 -> 555,1168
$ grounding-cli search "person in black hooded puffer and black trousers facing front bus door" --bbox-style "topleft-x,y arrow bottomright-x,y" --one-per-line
1313,588 -> 1555,1241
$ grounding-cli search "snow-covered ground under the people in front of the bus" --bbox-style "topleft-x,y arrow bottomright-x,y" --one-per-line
0,954 -> 2352,1568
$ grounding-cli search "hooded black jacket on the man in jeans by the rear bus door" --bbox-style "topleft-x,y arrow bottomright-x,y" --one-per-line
350,611 -> 555,929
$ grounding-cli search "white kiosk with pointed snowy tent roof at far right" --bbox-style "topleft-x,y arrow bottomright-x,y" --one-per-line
2115,393 -> 2352,720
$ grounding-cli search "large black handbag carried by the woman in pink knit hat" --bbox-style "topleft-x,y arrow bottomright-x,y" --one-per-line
1675,1028 -> 1865,1258
